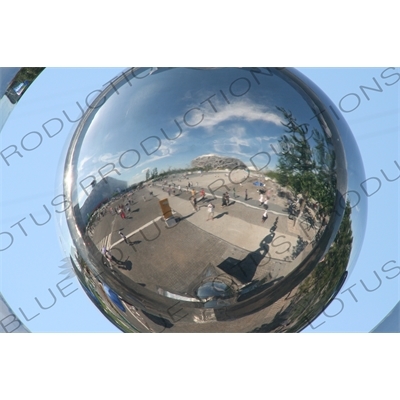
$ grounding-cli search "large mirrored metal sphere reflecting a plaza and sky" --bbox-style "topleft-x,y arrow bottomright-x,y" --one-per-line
59,68 -> 366,332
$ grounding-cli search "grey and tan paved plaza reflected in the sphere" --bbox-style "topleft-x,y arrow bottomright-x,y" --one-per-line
88,172 -> 318,304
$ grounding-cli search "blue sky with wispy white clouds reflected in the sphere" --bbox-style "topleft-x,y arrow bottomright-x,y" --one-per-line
74,68 -> 338,205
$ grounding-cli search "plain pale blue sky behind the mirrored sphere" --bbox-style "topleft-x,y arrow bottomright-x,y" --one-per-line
0,67 -> 400,332
